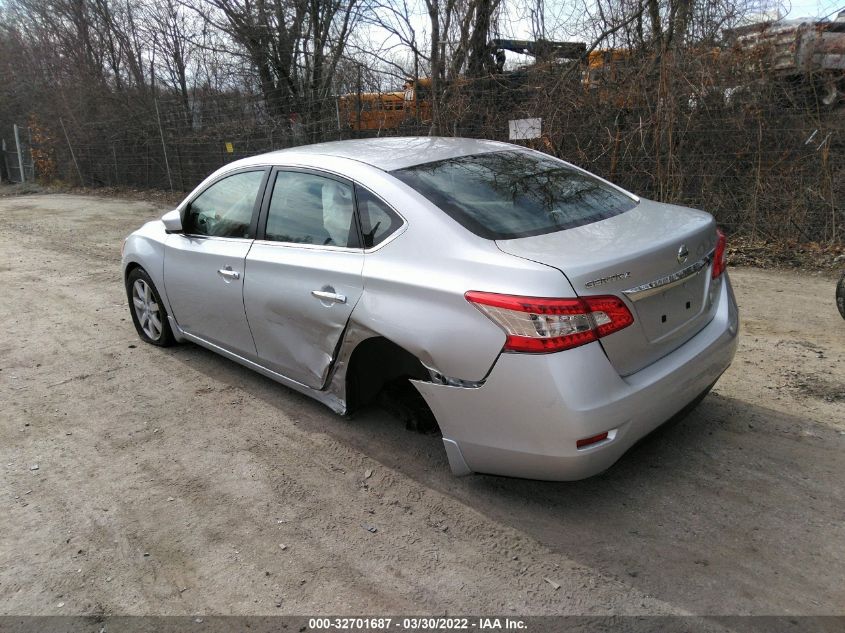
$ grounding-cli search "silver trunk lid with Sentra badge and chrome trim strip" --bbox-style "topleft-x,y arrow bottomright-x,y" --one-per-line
496,200 -> 717,376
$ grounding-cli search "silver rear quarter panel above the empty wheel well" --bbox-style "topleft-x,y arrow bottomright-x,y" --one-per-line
352,192 -> 572,382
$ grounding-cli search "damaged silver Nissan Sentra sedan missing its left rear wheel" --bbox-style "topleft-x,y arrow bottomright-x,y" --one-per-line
123,137 -> 738,480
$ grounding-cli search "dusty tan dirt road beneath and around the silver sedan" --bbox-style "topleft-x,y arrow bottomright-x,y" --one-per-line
0,195 -> 845,615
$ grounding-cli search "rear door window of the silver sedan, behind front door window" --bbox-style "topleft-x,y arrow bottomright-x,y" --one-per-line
264,171 -> 358,248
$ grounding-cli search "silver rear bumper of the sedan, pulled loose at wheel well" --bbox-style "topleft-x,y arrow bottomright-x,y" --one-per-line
415,275 -> 739,481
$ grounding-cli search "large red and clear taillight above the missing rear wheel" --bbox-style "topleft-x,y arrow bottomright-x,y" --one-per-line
465,290 -> 634,353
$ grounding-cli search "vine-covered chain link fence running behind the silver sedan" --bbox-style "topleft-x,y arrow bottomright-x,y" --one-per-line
6,73 -> 845,244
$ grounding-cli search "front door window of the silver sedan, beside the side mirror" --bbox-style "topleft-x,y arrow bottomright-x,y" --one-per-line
184,171 -> 264,237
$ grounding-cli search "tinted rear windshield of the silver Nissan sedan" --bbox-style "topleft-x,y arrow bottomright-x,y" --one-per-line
391,151 -> 637,240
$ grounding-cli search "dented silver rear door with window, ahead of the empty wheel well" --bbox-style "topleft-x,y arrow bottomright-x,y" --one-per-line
244,168 -> 364,389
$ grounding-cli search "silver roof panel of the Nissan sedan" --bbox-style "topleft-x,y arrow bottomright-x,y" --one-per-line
264,136 -> 517,171
